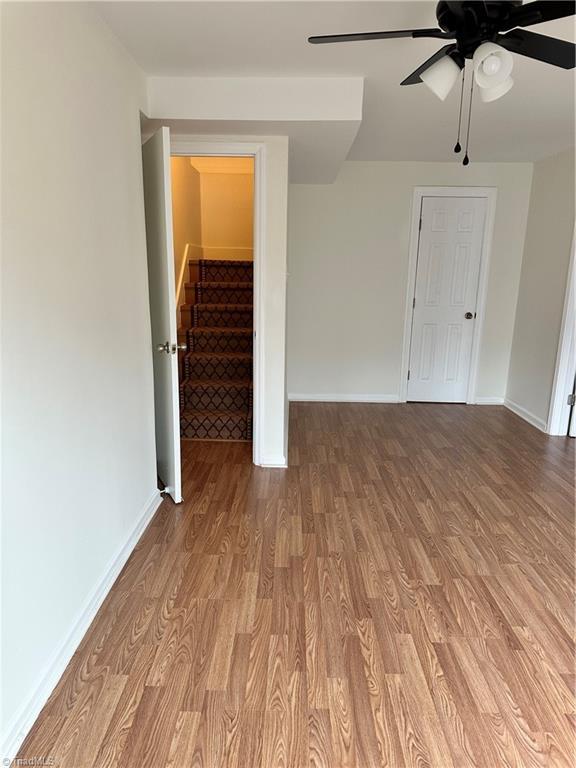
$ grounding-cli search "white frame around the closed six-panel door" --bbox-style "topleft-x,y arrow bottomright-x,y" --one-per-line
398,187 -> 501,405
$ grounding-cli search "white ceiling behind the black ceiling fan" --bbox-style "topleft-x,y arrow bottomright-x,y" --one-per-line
95,0 -> 575,161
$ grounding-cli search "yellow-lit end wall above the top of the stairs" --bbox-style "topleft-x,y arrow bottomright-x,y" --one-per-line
201,172 -> 254,258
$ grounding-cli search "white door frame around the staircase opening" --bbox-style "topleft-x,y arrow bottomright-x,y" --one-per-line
171,135 -> 266,465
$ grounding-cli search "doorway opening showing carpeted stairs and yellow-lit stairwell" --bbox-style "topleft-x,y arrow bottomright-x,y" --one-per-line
171,155 -> 254,442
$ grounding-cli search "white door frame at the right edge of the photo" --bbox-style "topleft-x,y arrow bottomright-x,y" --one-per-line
546,228 -> 576,436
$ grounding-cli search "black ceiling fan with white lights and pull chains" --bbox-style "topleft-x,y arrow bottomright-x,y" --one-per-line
308,0 -> 576,160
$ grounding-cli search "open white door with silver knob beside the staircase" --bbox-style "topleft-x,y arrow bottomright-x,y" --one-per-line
142,128 -> 182,503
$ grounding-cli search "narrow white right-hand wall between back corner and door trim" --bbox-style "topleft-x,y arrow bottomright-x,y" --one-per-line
507,150 -> 574,428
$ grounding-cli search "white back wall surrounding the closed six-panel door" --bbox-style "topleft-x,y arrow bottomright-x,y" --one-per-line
288,162 -> 532,400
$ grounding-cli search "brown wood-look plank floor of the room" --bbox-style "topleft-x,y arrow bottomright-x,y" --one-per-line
15,404 -> 576,768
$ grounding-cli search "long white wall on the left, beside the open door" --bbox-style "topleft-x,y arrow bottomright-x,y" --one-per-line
2,3 -> 158,755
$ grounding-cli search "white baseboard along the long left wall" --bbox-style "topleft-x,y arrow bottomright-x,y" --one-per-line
0,490 -> 162,760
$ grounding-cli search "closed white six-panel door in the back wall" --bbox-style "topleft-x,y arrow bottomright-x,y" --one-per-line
407,197 -> 486,403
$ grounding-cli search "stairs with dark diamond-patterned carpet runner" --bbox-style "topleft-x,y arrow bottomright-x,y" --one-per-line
179,259 -> 253,440
